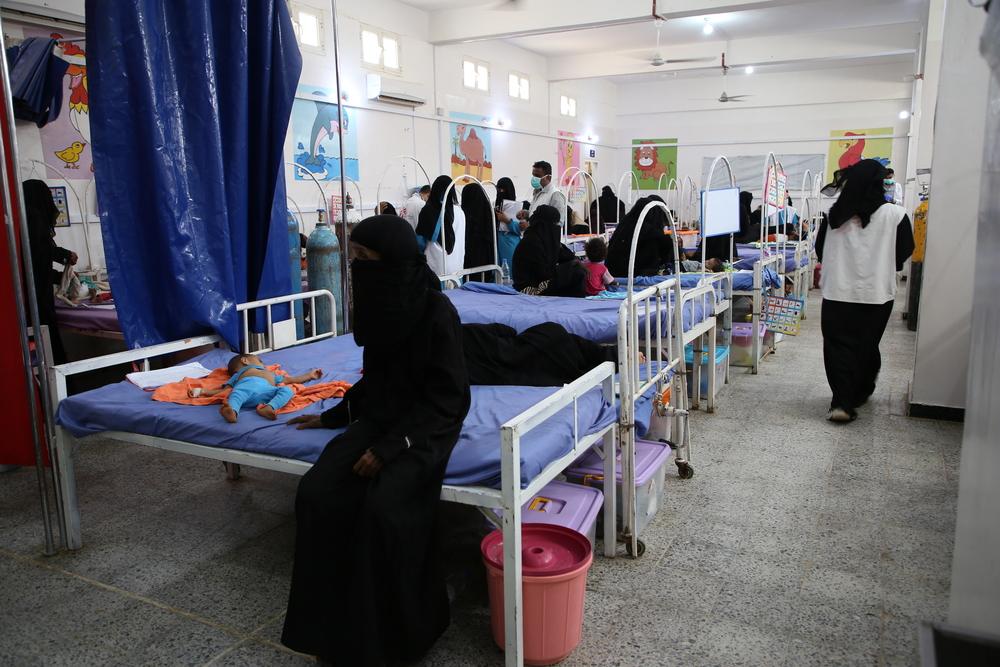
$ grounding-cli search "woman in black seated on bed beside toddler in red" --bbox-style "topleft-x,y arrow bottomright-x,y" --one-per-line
511,205 -> 587,297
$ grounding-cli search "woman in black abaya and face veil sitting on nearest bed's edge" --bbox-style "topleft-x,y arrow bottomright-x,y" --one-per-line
282,215 -> 470,666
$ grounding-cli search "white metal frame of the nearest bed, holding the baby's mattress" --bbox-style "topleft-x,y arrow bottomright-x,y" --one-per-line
50,290 -> 620,667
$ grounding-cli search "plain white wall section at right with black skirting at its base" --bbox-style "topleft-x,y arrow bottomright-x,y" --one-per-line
910,2 -> 989,408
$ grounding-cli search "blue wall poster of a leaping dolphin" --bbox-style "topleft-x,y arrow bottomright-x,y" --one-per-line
292,86 -> 361,181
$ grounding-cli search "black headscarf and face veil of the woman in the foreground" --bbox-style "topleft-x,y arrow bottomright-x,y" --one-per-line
351,215 -> 441,347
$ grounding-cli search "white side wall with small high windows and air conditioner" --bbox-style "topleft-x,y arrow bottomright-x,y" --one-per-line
286,0 -> 617,232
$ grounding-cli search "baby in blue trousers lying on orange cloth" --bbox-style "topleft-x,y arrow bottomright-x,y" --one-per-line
192,354 -> 323,424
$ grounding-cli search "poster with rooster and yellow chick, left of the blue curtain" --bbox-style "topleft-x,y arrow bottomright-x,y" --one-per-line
24,27 -> 94,180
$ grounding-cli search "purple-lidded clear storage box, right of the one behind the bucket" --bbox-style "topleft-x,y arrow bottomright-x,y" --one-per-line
566,440 -> 670,534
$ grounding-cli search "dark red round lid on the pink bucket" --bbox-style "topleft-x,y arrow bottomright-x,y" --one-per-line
480,523 -> 590,577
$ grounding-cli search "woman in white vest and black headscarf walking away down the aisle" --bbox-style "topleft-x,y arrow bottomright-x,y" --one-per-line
816,160 -> 913,422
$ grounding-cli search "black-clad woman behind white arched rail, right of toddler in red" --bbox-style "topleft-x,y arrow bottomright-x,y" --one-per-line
605,195 -> 674,278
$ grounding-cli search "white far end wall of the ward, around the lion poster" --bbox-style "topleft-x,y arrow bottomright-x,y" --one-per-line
617,63 -> 911,205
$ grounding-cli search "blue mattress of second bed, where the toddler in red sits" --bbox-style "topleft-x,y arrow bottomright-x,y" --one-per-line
445,283 -> 715,344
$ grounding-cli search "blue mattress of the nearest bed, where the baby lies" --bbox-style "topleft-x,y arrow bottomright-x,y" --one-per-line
56,335 -> 620,487
